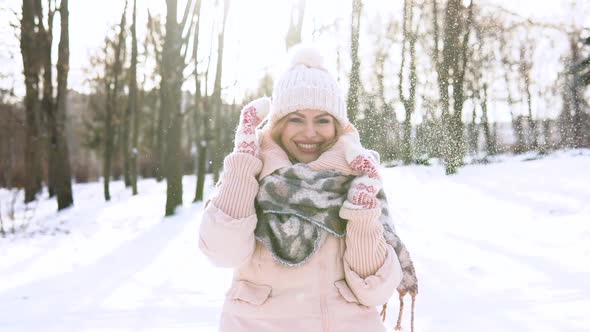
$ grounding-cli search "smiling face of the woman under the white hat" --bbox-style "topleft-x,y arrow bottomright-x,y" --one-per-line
279,109 -> 337,164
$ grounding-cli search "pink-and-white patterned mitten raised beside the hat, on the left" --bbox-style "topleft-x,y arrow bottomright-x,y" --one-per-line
234,97 -> 270,157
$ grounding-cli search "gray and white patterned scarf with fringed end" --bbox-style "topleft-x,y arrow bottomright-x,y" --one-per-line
255,164 -> 418,312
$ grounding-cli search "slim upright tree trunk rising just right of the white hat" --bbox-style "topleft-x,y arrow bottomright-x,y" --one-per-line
347,0 -> 363,124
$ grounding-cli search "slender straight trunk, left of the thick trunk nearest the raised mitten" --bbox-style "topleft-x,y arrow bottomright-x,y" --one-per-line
128,0 -> 139,195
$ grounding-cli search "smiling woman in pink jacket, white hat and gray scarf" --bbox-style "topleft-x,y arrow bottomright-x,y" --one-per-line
199,48 -> 417,332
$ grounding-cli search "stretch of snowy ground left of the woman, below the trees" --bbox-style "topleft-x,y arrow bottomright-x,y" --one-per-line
0,178 -> 230,332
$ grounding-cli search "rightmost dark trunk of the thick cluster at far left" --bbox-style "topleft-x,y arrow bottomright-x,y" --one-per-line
54,0 -> 74,210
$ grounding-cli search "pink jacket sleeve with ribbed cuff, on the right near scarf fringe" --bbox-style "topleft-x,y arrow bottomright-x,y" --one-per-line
340,207 -> 402,306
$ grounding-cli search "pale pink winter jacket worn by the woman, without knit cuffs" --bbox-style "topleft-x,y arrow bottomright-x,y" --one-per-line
199,127 -> 402,332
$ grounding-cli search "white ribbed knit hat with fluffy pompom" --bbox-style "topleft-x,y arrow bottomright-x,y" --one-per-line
270,45 -> 349,127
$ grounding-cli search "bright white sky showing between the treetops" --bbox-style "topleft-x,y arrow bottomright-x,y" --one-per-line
0,0 -> 590,121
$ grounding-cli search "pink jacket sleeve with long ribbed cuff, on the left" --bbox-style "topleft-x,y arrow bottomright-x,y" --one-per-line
199,153 -> 262,268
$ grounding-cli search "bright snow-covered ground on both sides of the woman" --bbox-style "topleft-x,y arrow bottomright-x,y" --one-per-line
0,150 -> 590,332
